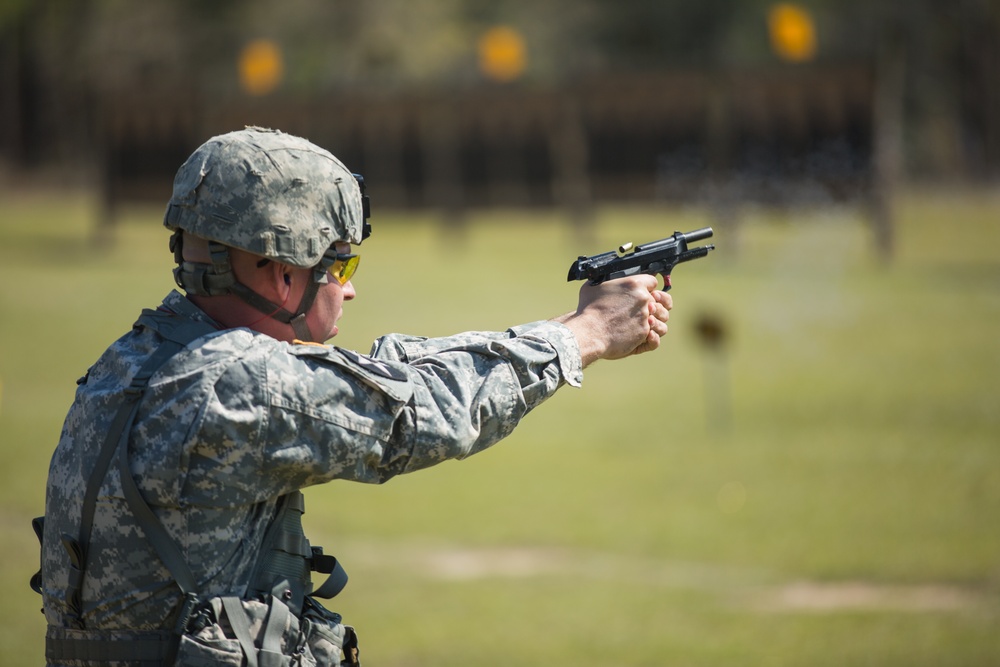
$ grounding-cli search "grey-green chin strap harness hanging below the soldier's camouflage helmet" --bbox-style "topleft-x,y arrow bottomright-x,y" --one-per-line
170,231 -> 320,341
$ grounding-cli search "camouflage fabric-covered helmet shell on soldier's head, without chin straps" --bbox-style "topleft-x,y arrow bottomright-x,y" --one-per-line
163,127 -> 371,268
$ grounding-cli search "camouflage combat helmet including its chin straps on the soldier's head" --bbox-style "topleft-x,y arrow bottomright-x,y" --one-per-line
163,127 -> 371,342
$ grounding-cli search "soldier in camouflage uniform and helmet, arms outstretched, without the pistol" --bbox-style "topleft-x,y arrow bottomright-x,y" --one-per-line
33,128 -> 672,667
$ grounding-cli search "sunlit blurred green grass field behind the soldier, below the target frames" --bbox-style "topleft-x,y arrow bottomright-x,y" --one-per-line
0,190 -> 1000,667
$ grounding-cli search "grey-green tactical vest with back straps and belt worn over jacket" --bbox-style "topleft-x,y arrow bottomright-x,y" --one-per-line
31,310 -> 357,667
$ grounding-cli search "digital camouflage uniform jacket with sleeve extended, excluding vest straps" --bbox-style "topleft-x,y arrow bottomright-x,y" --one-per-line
42,292 -> 582,631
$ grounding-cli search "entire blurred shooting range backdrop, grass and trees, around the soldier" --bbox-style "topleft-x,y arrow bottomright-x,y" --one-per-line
0,0 -> 1000,667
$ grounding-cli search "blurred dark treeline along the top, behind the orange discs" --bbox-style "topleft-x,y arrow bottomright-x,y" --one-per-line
0,0 -> 1000,179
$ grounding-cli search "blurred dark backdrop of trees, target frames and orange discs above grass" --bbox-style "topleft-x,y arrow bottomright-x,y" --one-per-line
0,0 -> 1000,236
